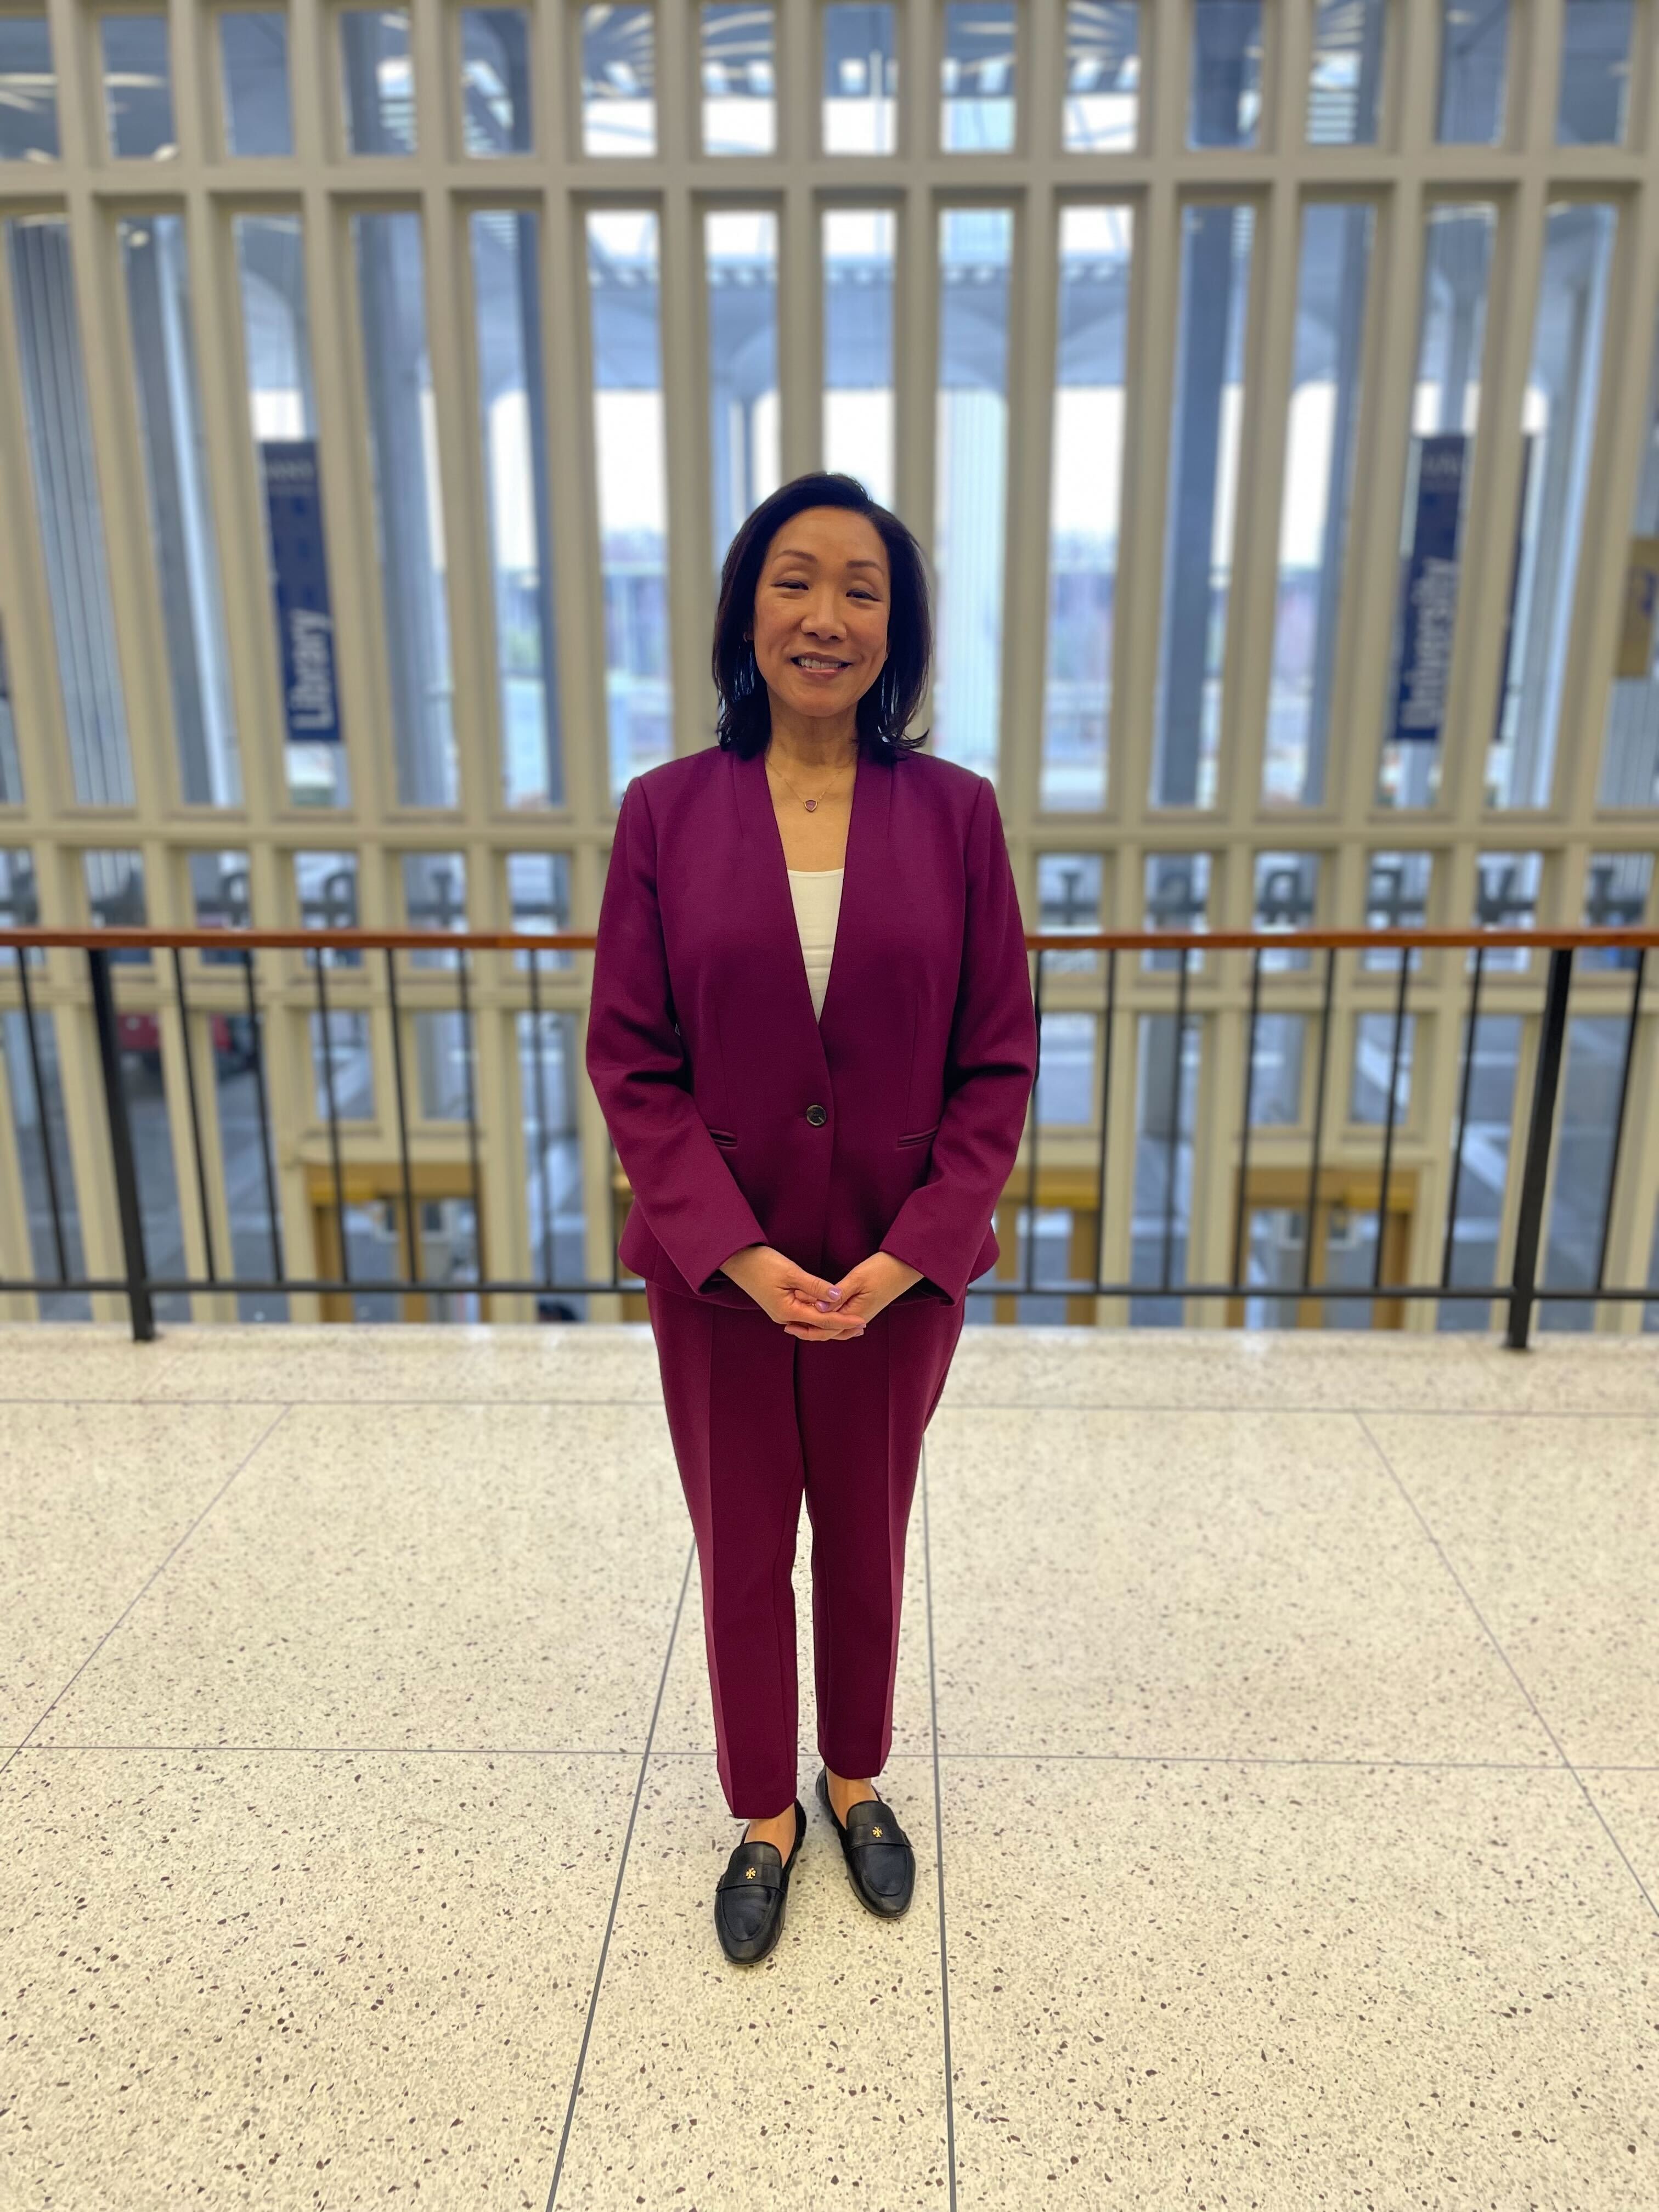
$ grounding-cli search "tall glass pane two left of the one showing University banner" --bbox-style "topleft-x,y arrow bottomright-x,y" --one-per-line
1153,206 -> 1254,808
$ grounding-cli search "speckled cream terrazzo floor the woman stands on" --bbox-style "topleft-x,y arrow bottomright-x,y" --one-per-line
0,1325 -> 1659,2212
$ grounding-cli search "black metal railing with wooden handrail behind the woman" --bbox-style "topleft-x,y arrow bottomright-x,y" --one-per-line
0,929 -> 1659,1350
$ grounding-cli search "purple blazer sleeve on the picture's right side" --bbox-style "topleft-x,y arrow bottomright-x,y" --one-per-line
881,776 -> 1037,1305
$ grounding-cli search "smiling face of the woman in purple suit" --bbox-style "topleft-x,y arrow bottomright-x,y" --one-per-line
750,506 -> 889,719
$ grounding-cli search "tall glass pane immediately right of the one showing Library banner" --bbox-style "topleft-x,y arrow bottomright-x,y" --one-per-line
352,212 -> 456,808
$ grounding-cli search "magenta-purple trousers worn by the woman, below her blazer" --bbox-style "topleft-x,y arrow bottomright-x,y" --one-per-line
646,1283 -> 964,1820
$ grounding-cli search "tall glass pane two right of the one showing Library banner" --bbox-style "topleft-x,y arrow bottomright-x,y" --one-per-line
471,208 -> 564,808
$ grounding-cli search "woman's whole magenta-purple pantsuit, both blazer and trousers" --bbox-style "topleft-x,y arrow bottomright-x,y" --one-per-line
586,748 -> 1037,1820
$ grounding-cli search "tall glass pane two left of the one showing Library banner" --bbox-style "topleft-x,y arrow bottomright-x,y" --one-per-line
7,215 -> 133,808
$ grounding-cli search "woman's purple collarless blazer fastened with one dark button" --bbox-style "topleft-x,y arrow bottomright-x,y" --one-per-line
586,746 -> 1037,1307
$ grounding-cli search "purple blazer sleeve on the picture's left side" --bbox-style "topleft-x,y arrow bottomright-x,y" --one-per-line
586,776 -> 768,1290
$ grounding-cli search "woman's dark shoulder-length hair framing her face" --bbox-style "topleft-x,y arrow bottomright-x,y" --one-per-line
714,471 -> 934,763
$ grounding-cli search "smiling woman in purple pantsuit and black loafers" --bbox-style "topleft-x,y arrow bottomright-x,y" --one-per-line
586,476 -> 1037,1964
